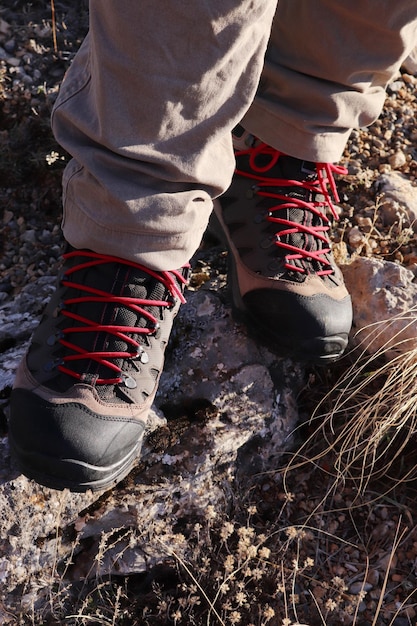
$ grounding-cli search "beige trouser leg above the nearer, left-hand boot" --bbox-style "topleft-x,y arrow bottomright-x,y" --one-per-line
52,0 -> 276,270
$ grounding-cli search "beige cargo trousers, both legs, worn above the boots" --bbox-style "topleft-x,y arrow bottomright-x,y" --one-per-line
52,0 -> 417,270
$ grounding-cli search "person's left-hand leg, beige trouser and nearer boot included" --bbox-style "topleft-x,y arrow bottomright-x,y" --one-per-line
9,0 -> 274,490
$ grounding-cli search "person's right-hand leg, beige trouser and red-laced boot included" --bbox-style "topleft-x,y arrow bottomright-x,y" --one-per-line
216,0 -> 417,362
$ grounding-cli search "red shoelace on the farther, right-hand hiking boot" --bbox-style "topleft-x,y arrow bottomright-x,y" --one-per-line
235,143 -> 347,276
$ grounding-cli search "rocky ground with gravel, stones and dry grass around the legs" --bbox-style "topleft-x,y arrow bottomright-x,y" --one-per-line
0,0 -> 417,626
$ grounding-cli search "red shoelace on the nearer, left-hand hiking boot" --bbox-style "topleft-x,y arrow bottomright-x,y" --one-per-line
54,250 -> 189,385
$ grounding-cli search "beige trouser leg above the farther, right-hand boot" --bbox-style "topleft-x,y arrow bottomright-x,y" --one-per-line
243,0 -> 417,162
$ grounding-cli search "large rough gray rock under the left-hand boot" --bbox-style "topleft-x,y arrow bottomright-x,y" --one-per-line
0,274 -> 303,623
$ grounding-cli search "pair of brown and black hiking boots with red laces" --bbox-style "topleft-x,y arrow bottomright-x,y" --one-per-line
9,133 -> 352,491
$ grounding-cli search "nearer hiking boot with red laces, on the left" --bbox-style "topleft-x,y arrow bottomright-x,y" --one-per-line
9,249 -> 188,491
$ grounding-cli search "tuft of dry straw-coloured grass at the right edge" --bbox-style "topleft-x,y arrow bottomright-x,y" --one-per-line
286,312 -> 417,496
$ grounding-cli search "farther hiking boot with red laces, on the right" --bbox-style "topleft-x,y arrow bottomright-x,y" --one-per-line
215,127 -> 352,362
